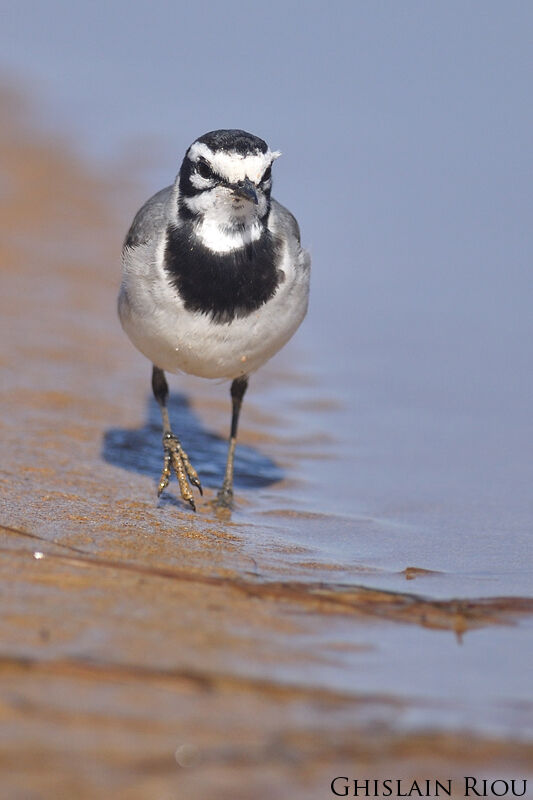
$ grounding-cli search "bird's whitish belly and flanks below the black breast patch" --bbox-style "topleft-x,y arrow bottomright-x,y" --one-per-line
119,241 -> 309,378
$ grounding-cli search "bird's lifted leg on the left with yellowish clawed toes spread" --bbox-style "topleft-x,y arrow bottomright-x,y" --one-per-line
152,365 -> 203,511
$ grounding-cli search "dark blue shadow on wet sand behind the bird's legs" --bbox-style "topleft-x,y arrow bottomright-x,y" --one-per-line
102,394 -> 283,496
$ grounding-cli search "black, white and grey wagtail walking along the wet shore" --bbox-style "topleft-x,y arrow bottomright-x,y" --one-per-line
118,129 -> 311,511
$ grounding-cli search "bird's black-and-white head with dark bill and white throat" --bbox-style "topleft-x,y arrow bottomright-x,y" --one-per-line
177,130 -> 281,252
